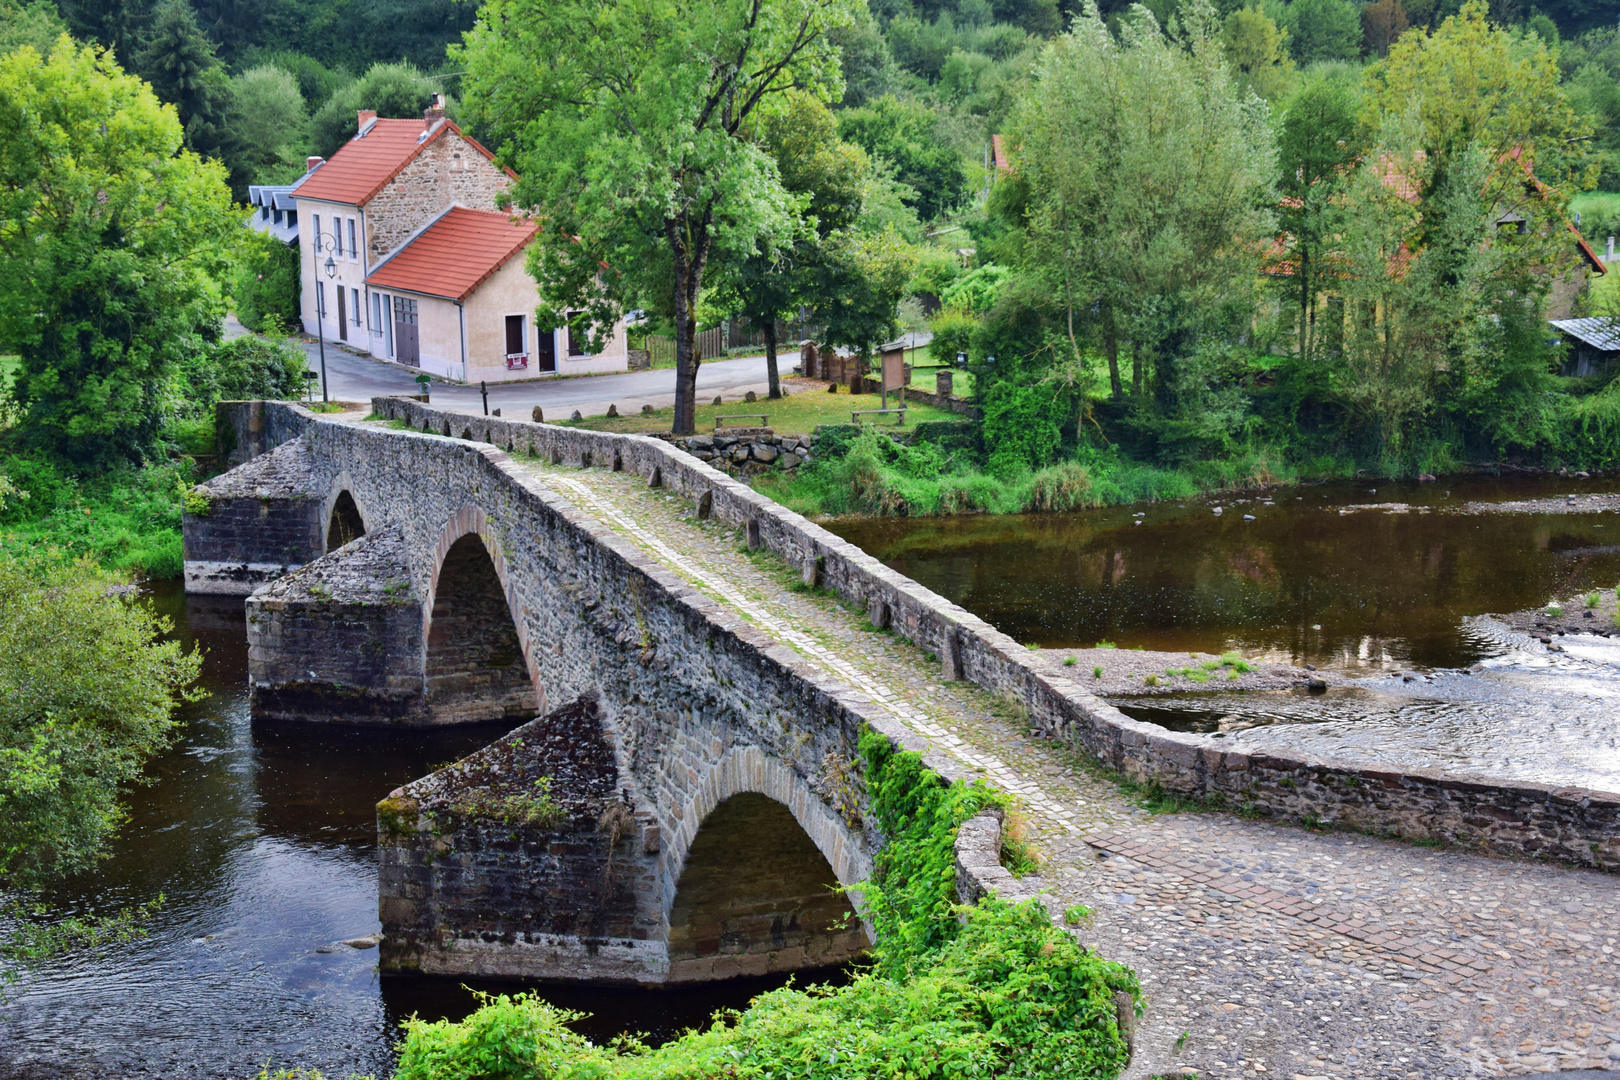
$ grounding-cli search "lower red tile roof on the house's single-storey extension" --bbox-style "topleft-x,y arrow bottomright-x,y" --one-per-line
366,206 -> 539,300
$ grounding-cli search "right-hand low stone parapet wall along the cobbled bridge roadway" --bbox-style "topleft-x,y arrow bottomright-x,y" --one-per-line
374,398 -> 1620,870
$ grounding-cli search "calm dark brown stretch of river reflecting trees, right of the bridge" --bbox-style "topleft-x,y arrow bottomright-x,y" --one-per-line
839,502 -> 1620,665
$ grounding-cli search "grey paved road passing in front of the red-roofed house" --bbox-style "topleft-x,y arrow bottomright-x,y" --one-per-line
289,330 -> 777,419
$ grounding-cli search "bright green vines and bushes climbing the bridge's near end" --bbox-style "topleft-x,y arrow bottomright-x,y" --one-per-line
364,732 -> 1140,1080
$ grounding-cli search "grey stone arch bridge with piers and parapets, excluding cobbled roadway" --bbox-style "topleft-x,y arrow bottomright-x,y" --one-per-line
185,398 -> 1620,983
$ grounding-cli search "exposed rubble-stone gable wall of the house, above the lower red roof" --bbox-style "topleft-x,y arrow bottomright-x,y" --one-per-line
366,130 -> 512,266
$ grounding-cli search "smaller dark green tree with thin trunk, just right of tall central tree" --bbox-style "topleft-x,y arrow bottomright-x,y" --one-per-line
714,91 -> 870,398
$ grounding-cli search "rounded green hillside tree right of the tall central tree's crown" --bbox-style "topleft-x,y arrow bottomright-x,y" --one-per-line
838,96 -> 967,222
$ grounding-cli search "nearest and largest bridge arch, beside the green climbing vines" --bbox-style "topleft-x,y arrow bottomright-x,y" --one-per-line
664,746 -> 872,981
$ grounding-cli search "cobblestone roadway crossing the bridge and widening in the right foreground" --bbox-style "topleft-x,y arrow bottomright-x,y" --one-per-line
525,463 -> 1620,1080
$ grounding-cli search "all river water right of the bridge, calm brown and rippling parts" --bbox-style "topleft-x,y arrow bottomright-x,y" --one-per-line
828,478 -> 1620,790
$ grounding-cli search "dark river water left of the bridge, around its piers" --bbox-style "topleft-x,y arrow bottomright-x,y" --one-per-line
0,585 -> 810,1080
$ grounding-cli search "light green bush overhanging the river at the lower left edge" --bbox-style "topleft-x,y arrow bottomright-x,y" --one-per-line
0,554 -> 201,981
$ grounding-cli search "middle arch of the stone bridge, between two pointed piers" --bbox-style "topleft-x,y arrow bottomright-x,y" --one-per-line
421,505 -> 546,724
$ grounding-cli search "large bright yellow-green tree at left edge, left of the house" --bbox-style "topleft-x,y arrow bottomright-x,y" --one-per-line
0,37 -> 241,466
